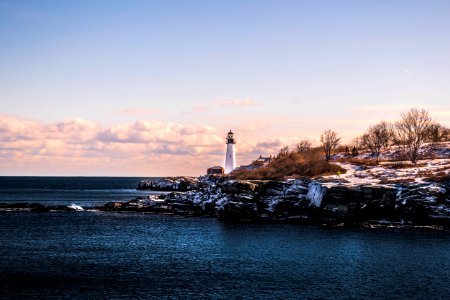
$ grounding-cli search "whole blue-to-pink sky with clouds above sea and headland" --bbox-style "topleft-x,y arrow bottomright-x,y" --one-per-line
0,0 -> 450,176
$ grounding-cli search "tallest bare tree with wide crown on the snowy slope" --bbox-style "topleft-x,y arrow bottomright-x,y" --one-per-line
395,108 -> 433,164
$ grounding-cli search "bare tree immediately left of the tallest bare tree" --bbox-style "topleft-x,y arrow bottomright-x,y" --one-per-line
361,121 -> 393,162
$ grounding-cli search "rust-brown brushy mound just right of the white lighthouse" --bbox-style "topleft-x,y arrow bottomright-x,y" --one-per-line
232,149 -> 346,180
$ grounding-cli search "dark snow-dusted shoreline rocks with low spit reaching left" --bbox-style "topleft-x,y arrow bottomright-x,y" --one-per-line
0,176 -> 450,228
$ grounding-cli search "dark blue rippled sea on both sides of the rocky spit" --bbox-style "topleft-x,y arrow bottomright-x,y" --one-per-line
0,177 -> 450,299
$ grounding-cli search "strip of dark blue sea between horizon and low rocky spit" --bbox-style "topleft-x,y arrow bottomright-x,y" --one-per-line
0,176 -> 158,206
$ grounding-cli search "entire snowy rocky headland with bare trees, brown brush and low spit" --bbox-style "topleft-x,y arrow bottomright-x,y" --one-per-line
0,109 -> 450,229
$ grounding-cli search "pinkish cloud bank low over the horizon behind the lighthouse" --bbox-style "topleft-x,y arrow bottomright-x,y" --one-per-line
0,115 -> 324,176
